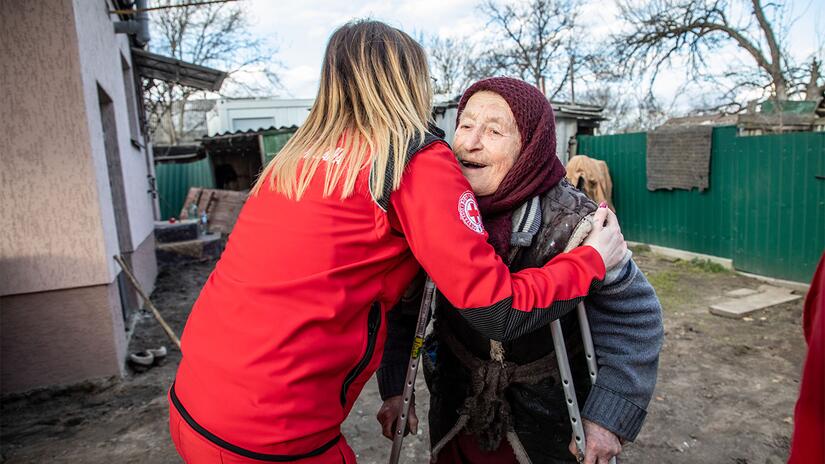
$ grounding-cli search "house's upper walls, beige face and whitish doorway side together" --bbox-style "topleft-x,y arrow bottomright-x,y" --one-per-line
0,0 -> 159,295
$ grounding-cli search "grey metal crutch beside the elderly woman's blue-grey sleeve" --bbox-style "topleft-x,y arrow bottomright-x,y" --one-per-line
550,302 -> 616,464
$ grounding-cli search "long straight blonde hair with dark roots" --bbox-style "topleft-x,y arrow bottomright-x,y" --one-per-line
252,20 -> 432,199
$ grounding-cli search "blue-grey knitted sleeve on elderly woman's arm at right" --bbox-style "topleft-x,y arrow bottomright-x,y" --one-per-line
582,260 -> 664,441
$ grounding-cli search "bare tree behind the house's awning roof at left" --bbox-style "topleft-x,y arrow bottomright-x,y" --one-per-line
144,0 -> 279,145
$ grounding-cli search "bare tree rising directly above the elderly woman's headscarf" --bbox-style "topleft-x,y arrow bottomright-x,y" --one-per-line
480,0 -> 585,99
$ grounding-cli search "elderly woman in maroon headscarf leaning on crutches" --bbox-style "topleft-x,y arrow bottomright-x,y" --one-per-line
378,77 -> 663,464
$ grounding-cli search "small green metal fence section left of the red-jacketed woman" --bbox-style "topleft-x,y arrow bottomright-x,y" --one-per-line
155,157 -> 215,220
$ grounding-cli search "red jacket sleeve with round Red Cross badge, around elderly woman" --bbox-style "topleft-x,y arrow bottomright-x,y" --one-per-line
389,143 -> 605,340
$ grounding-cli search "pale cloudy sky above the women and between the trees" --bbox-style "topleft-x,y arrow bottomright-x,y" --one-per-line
242,0 -> 825,111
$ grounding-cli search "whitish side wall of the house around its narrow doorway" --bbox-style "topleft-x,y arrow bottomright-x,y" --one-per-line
74,0 -> 154,281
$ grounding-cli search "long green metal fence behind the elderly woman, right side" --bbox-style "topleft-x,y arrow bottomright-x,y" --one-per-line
578,127 -> 825,282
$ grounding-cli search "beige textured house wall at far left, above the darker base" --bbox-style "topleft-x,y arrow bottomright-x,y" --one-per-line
0,0 -> 113,296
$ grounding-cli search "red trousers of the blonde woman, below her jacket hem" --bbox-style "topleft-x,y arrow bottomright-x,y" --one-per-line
169,398 -> 356,464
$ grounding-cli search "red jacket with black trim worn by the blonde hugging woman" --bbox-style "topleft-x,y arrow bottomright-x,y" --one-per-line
170,141 -> 605,460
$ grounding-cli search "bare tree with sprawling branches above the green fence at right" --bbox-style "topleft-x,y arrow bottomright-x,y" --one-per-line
612,0 -> 825,111
